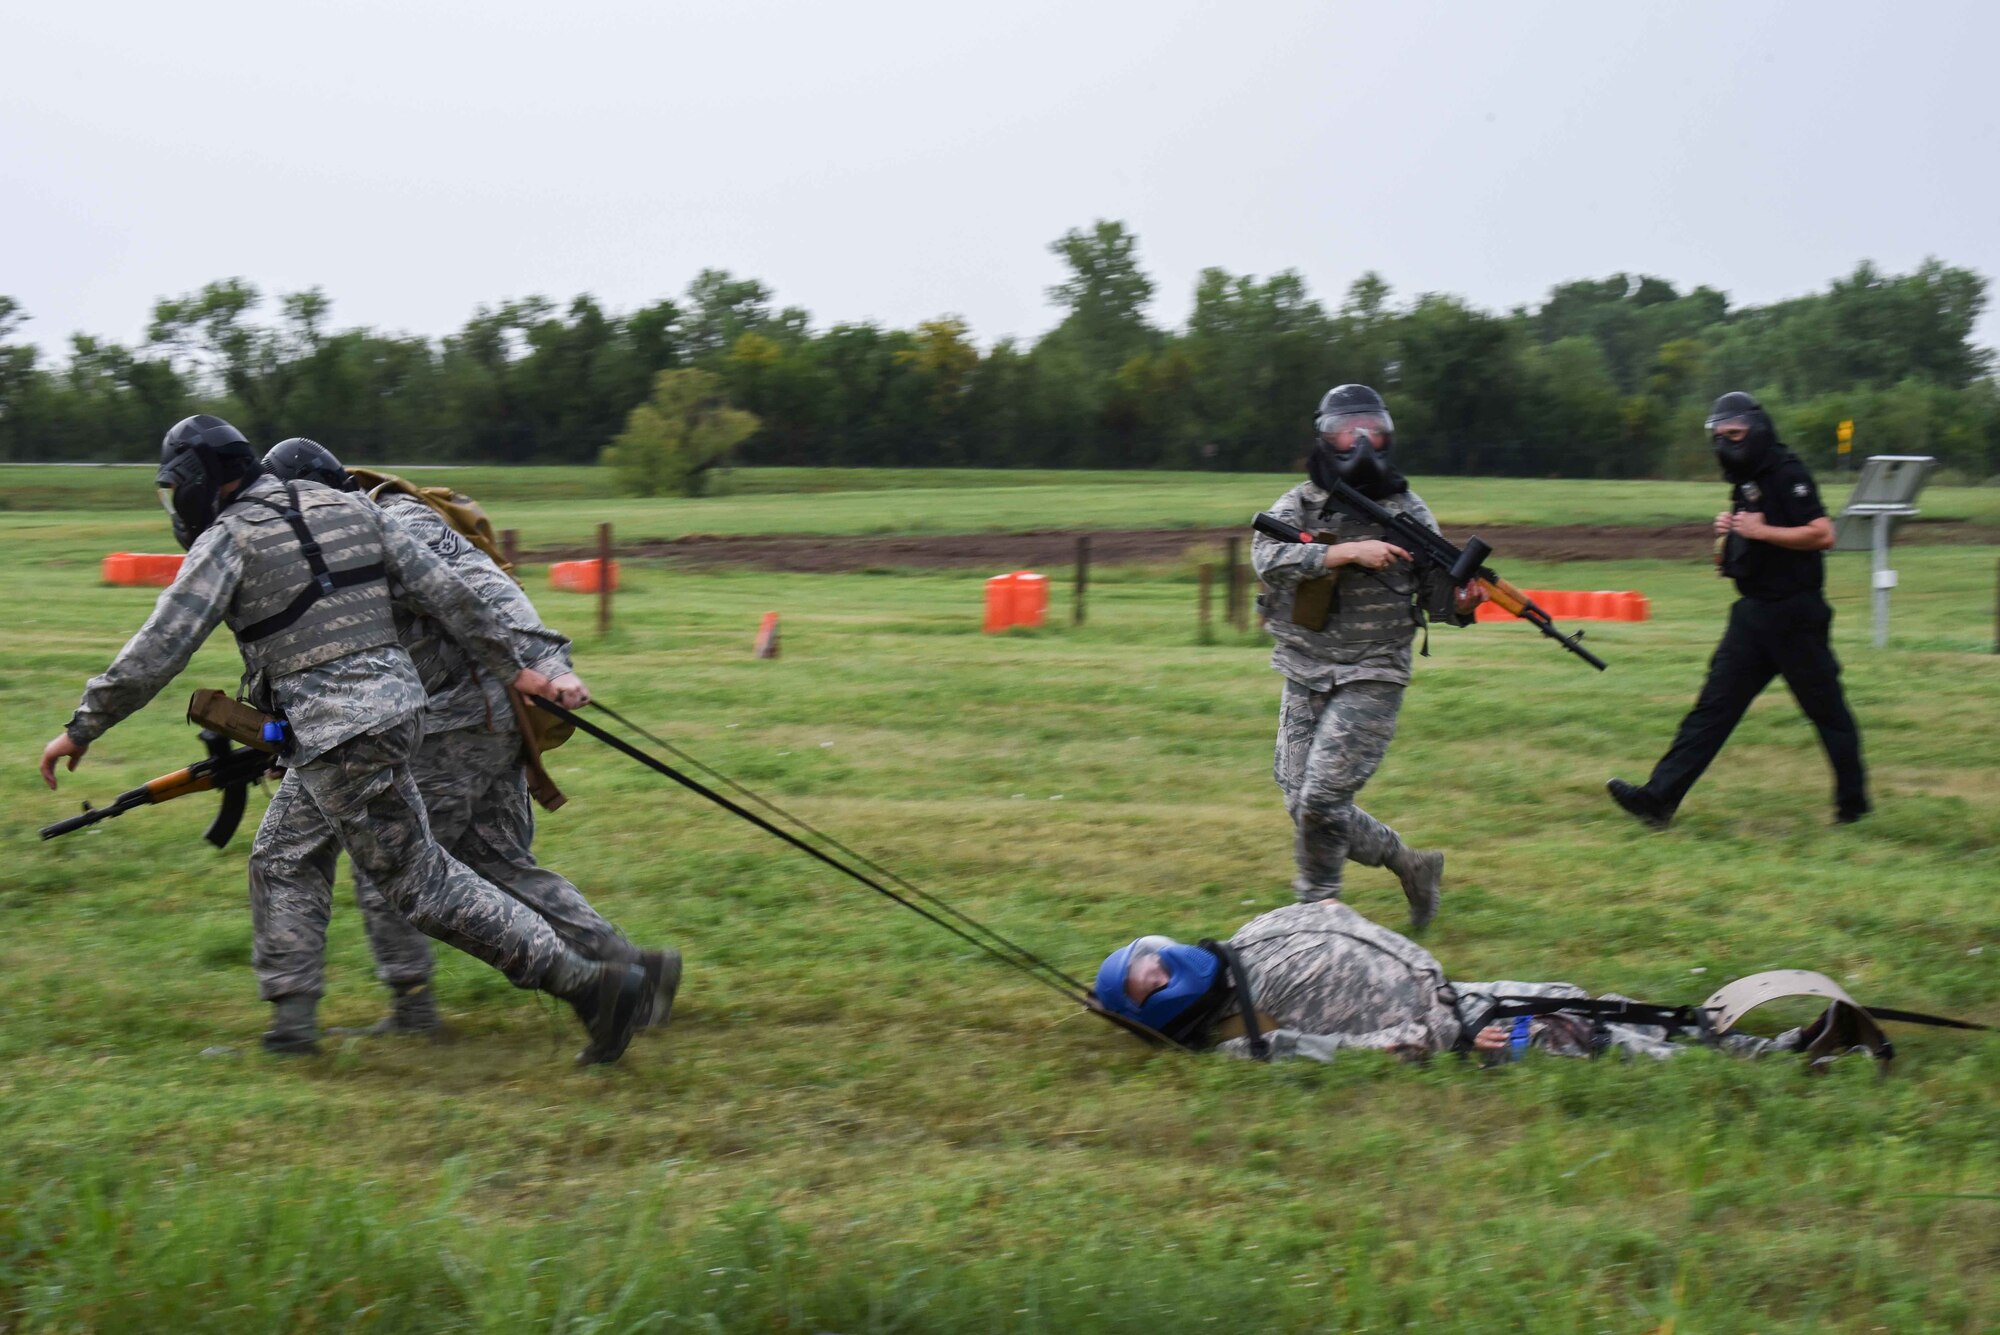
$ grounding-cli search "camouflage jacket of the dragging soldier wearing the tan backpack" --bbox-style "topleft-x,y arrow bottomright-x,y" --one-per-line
382,492 -> 572,737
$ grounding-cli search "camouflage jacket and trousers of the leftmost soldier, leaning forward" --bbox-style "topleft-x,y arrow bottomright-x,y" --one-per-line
66,476 -> 600,995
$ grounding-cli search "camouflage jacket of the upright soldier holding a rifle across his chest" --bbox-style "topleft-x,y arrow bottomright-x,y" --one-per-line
1250,482 -> 1472,691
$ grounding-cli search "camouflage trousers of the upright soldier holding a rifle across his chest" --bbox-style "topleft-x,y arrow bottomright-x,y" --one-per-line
1272,679 -> 1404,903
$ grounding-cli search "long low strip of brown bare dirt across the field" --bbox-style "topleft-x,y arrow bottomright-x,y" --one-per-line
522,520 -> 2000,572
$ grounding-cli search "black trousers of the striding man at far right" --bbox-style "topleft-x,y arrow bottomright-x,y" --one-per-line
1646,592 -> 1868,813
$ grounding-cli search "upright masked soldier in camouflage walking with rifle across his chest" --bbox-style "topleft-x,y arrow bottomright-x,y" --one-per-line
1250,386 -> 1482,927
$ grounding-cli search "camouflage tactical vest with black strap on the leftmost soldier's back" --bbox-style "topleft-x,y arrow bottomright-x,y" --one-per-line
218,484 -> 396,687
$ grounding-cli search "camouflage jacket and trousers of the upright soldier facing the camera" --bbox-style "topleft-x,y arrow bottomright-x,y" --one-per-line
1250,482 -> 1472,901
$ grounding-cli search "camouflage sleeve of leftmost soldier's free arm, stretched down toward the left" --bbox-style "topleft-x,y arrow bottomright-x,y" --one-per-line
64,524 -> 244,743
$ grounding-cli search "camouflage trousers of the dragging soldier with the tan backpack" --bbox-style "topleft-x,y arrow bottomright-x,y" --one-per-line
354,727 -> 638,987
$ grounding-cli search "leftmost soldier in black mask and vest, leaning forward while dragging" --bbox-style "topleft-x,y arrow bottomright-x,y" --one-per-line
42,416 -> 666,1061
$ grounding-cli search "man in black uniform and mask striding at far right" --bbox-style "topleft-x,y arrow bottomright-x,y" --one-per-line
1606,392 -> 1870,829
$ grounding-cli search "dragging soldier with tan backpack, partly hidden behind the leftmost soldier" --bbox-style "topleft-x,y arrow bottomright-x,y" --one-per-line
250,438 -> 660,1033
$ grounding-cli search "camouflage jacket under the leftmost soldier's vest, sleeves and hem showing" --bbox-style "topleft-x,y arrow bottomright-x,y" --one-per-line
66,476 -> 520,765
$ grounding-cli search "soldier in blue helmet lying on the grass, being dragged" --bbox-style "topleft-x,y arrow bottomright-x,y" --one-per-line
1094,899 -> 1798,1061
